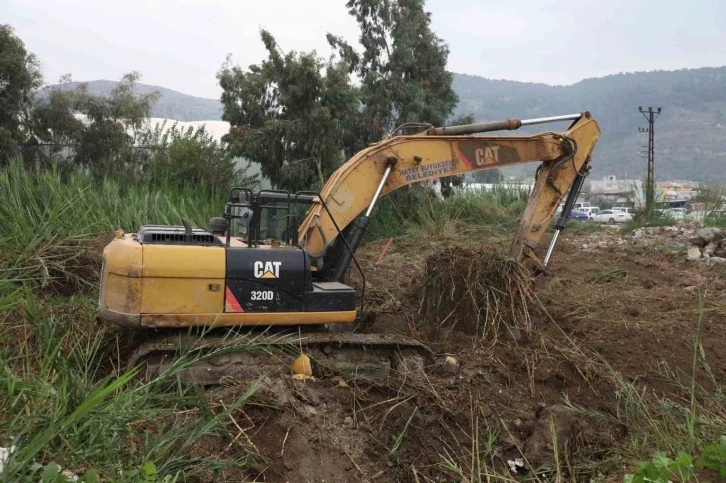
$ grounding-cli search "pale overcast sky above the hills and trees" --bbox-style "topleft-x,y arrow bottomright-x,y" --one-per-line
0,0 -> 726,98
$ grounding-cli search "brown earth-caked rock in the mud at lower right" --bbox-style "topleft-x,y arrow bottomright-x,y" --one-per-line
524,404 -> 575,469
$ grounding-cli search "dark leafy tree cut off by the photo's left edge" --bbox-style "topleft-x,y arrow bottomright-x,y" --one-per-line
0,25 -> 43,161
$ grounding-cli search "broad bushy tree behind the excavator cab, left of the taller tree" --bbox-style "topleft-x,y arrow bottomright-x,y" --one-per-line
217,30 -> 359,191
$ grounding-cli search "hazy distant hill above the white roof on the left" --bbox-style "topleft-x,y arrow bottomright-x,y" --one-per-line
40,80 -> 222,121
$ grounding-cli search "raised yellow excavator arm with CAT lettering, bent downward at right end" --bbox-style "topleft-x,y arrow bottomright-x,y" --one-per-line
298,112 -> 600,279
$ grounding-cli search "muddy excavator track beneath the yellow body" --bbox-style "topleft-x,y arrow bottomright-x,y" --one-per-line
126,331 -> 435,385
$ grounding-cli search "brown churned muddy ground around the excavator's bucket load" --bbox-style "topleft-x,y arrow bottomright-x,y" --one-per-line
193,234 -> 726,482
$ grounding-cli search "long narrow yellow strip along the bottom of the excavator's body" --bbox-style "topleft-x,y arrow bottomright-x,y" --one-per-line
141,310 -> 356,328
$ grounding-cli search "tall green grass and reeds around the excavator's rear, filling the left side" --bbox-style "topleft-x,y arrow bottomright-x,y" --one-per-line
0,164 -> 257,482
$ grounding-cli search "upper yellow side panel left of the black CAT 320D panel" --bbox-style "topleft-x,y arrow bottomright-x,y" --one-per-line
142,245 -> 225,279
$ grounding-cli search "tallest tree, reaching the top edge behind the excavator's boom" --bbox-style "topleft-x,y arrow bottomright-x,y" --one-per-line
327,0 -> 458,155
